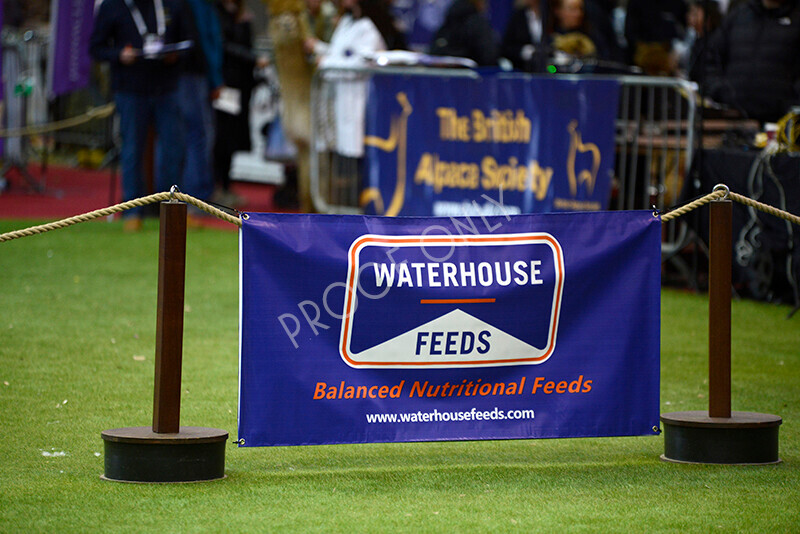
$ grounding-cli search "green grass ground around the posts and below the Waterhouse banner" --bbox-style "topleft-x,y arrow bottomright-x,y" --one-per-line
0,221 -> 800,532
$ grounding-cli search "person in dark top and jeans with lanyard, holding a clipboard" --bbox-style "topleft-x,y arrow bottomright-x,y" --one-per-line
89,0 -> 188,231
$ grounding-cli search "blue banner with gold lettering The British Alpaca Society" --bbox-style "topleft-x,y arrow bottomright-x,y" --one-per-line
360,74 -> 619,216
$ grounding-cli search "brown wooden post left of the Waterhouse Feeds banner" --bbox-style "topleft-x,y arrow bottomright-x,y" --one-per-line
153,202 -> 186,434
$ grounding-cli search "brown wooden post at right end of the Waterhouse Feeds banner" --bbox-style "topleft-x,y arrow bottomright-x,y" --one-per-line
708,200 -> 733,418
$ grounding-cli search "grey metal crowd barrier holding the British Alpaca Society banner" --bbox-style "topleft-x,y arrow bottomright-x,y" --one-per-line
311,67 -> 698,266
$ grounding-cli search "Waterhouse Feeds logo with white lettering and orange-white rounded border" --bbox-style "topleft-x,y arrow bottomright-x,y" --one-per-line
339,233 -> 564,369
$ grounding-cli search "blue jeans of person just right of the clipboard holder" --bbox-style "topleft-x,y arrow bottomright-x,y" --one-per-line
178,74 -> 214,200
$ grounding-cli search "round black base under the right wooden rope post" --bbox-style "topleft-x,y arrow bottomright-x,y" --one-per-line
661,412 -> 783,465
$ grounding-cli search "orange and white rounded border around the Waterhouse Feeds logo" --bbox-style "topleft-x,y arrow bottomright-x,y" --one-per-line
340,233 -> 564,367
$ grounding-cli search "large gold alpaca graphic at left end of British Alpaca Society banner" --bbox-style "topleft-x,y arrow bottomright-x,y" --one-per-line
359,93 -> 413,217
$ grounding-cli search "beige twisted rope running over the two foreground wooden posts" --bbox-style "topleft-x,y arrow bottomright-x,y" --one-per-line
0,186 -> 800,243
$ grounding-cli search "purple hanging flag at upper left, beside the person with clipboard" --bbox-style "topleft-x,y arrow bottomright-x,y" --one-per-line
48,0 -> 94,97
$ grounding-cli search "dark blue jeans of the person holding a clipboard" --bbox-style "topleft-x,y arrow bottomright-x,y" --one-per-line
114,91 -> 181,216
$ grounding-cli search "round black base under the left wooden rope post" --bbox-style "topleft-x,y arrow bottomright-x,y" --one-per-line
101,426 -> 228,482
